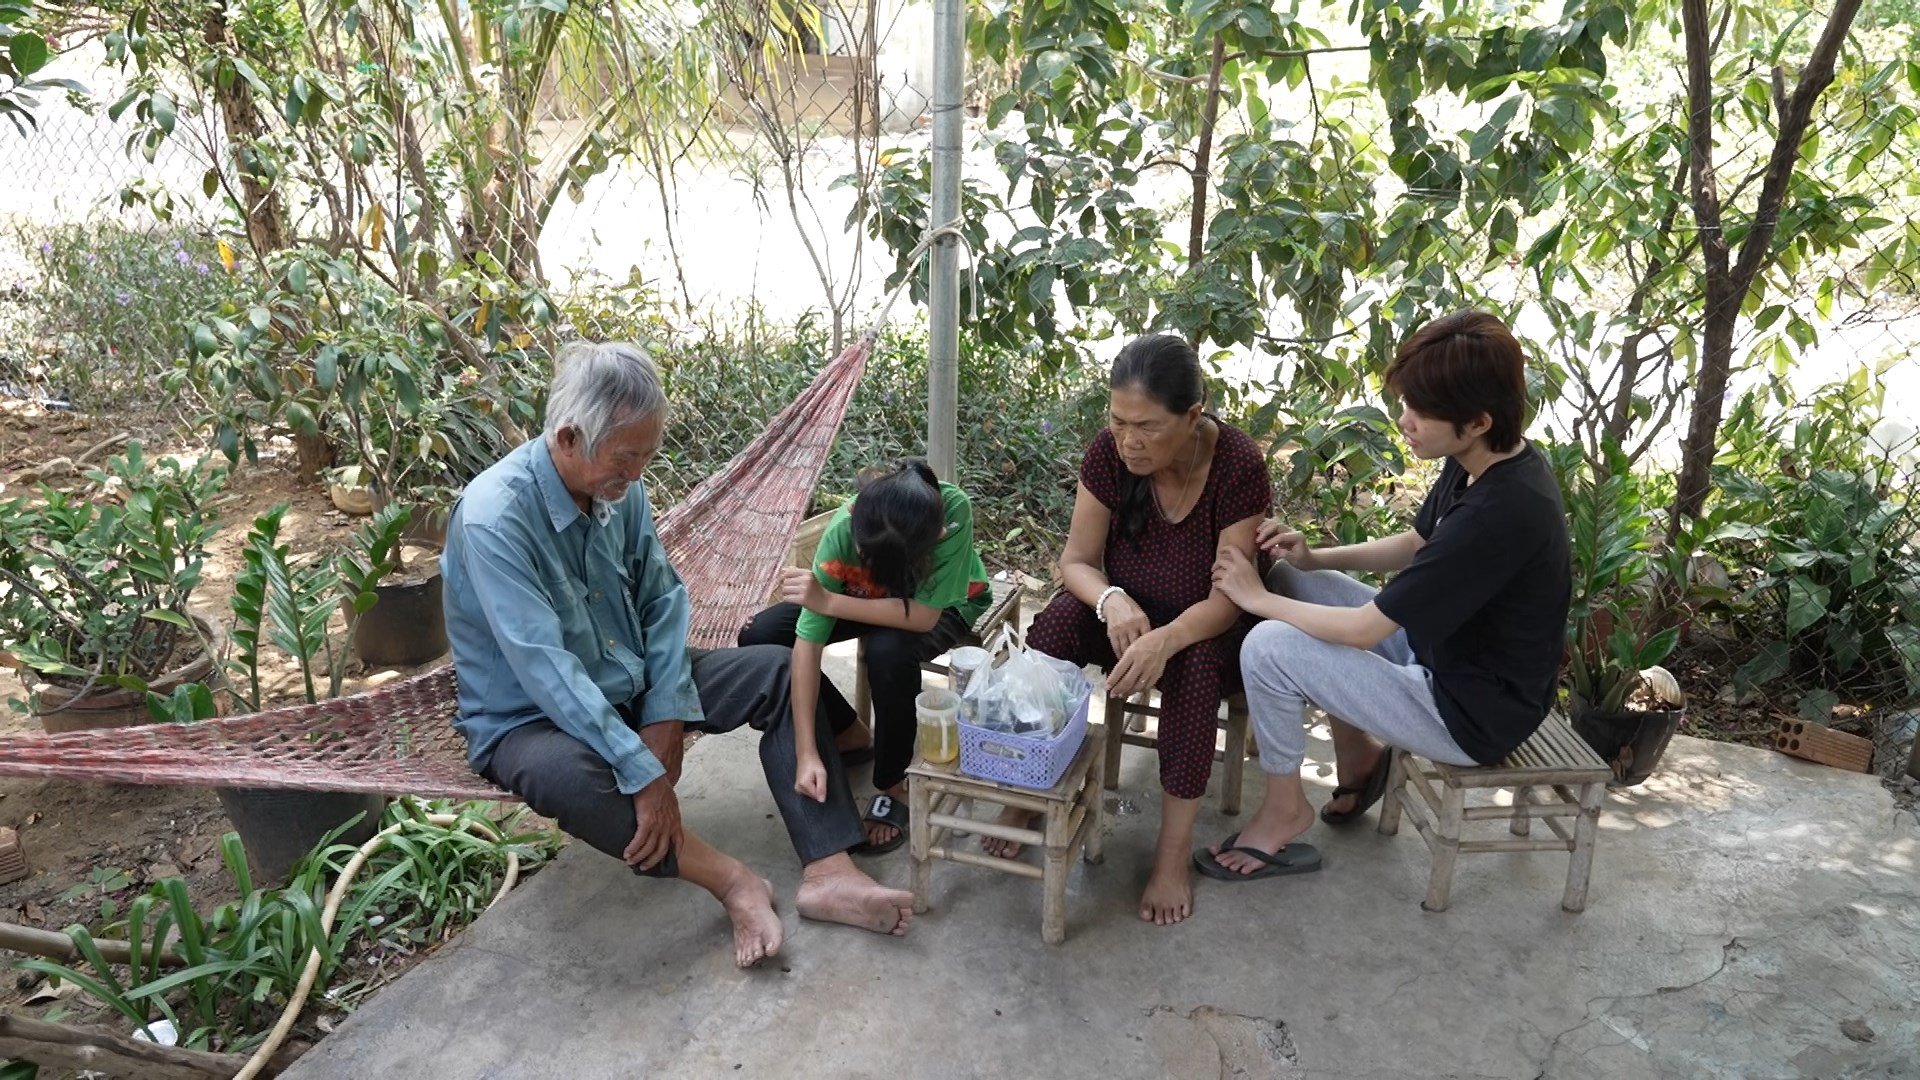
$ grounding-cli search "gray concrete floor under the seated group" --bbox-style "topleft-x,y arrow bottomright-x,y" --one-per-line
286,641 -> 1920,1080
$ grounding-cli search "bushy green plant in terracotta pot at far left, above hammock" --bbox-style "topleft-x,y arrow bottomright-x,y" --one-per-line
0,442 -> 227,732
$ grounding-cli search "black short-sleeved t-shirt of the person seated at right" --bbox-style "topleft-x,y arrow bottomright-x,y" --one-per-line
1373,444 -> 1572,765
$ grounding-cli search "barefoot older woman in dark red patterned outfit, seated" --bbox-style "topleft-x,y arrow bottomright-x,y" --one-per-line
985,334 -> 1273,926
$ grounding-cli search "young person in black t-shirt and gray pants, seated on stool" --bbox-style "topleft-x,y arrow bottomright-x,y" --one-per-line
1194,311 -> 1572,880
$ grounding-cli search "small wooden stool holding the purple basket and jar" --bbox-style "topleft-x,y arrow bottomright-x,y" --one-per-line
906,724 -> 1106,945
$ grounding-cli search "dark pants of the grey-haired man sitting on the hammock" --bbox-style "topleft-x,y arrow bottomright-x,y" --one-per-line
484,646 -> 866,876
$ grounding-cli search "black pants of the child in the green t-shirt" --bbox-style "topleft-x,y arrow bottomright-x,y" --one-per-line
739,603 -> 973,792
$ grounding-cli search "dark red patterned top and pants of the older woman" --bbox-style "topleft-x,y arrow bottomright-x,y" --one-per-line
1027,417 -> 1273,799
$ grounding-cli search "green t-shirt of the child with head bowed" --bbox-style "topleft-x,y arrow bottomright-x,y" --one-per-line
793,484 -> 993,646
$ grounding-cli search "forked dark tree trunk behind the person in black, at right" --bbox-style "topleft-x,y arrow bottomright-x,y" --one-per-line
1668,0 -> 1860,534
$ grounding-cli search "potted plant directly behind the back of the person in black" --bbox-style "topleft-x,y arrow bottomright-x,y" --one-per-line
1553,438 -> 1686,784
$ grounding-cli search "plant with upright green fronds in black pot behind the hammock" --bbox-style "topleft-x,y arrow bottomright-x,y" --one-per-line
210,503 -> 409,882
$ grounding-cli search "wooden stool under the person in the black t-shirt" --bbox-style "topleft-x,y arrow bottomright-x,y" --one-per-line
1380,713 -> 1613,911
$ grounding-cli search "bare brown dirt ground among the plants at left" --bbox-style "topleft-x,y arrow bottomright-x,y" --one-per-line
0,398 -> 472,1032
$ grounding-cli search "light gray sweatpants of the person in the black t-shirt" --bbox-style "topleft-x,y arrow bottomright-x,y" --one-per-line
1240,563 -> 1475,774
